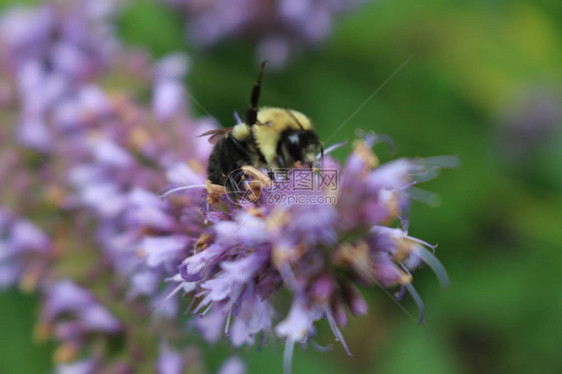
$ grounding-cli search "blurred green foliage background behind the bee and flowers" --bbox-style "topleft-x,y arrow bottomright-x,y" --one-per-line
0,0 -> 562,374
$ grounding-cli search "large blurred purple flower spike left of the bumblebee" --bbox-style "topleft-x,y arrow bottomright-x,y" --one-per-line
0,0 -> 214,373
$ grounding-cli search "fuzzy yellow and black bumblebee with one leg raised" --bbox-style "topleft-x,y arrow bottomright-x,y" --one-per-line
200,61 -> 324,190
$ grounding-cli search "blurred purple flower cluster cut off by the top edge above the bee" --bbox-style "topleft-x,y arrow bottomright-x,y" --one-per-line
162,0 -> 364,68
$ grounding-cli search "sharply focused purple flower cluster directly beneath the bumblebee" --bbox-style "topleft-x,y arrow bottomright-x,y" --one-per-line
152,135 -> 454,372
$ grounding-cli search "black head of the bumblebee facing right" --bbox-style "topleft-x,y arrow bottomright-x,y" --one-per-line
276,129 -> 320,168
